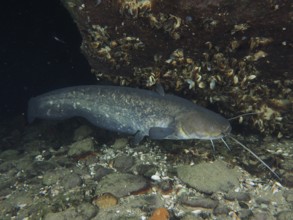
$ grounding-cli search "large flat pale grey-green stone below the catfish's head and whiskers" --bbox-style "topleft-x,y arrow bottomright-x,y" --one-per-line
177,160 -> 240,194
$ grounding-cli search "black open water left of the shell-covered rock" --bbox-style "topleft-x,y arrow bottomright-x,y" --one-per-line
0,0 -> 95,116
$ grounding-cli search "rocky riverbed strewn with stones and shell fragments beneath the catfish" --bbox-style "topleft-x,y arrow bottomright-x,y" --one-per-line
0,117 -> 293,220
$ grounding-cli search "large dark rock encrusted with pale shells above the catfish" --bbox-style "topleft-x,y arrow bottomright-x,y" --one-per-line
63,0 -> 293,138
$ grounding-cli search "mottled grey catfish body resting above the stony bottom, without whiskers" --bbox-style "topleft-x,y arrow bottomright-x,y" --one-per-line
28,85 -> 231,143
